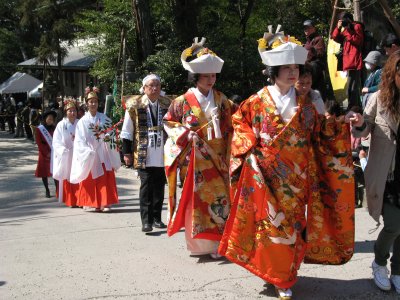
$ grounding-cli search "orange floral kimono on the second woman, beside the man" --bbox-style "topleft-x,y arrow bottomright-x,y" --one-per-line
164,90 -> 233,243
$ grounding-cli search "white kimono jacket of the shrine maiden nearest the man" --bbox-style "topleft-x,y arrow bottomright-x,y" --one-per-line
70,112 -> 121,183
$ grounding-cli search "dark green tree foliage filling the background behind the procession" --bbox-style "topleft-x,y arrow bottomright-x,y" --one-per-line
0,0 -> 400,119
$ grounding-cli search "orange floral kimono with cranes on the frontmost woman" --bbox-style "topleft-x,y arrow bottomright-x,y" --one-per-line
219,88 -> 354,288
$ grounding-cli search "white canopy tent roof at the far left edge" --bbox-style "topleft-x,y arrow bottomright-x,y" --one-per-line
0,72 -> 41,94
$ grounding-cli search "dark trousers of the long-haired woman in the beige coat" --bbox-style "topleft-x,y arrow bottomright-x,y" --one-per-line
374,203 -> 400,275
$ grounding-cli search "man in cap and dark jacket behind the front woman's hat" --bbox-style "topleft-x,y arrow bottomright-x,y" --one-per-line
303,20 -> 326,101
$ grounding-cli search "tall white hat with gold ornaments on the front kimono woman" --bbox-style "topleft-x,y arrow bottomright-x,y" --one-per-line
258,25 -> 308,66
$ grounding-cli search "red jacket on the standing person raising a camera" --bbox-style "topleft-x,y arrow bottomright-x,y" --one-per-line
332,22 -> 364,71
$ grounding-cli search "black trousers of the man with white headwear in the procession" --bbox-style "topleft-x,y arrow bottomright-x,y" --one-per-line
138,167 -> 166,224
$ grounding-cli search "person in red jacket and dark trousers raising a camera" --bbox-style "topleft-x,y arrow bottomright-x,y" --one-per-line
331,12 -> 364,108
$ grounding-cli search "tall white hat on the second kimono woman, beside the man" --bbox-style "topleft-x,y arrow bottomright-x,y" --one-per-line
181,37 -> 224,74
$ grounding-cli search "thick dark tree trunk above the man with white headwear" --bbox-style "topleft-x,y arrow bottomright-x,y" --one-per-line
132,0 -> 153,62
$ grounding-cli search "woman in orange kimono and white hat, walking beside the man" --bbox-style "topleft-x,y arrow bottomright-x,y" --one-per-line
164,38 -> 233,258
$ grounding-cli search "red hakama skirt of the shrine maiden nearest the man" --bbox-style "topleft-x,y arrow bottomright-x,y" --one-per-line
77,164 -> 118,208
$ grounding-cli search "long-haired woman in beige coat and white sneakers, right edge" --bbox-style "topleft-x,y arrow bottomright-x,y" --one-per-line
346,50 -> 400,294
